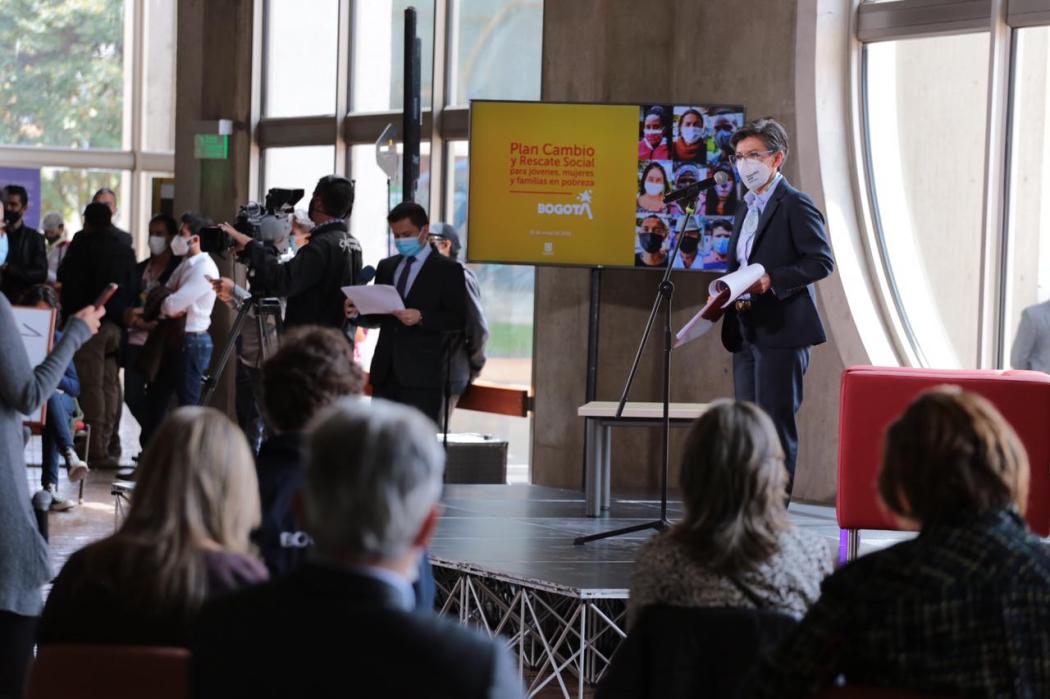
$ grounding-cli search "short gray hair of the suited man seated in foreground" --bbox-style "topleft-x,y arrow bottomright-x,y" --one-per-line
305,398 -> 445,559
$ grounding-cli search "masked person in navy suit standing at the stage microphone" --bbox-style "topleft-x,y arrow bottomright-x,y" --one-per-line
721,119 -> 835,496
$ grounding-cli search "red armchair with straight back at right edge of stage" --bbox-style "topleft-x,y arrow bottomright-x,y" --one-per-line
836,366 -> 1050,560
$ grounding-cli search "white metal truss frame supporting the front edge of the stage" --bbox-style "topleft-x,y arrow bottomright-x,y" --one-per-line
431,556 -> 627,698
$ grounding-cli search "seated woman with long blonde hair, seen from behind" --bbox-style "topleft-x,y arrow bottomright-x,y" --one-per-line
39,407 -> 267,645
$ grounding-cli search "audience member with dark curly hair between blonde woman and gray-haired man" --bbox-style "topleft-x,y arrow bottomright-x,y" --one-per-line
254,325 -> 364,578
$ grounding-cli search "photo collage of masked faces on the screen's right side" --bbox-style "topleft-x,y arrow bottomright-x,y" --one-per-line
634,104 -> 743,272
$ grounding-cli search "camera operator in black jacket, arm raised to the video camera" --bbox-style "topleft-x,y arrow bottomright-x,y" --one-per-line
223,175 -> 361,329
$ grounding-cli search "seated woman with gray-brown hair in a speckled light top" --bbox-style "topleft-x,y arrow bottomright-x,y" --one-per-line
628,401 -> 834,622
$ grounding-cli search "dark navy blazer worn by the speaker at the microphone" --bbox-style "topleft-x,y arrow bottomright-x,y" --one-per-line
721,178 -> 835,352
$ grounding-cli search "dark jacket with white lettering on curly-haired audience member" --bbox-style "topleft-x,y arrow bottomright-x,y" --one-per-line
252,432 -> 309,578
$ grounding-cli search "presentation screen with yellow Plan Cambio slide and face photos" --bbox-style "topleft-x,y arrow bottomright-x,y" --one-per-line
466,101 -> 744,272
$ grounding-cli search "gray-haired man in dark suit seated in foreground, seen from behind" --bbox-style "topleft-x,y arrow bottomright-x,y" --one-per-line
191,398 -> 522,699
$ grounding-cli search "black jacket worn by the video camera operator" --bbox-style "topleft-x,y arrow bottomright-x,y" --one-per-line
245,220 -> 361,329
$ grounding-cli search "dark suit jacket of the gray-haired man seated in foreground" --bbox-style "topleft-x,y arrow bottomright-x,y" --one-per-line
191,564 -> 522,699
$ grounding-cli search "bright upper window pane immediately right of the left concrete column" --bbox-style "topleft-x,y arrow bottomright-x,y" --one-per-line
263,0 -> 339,117
